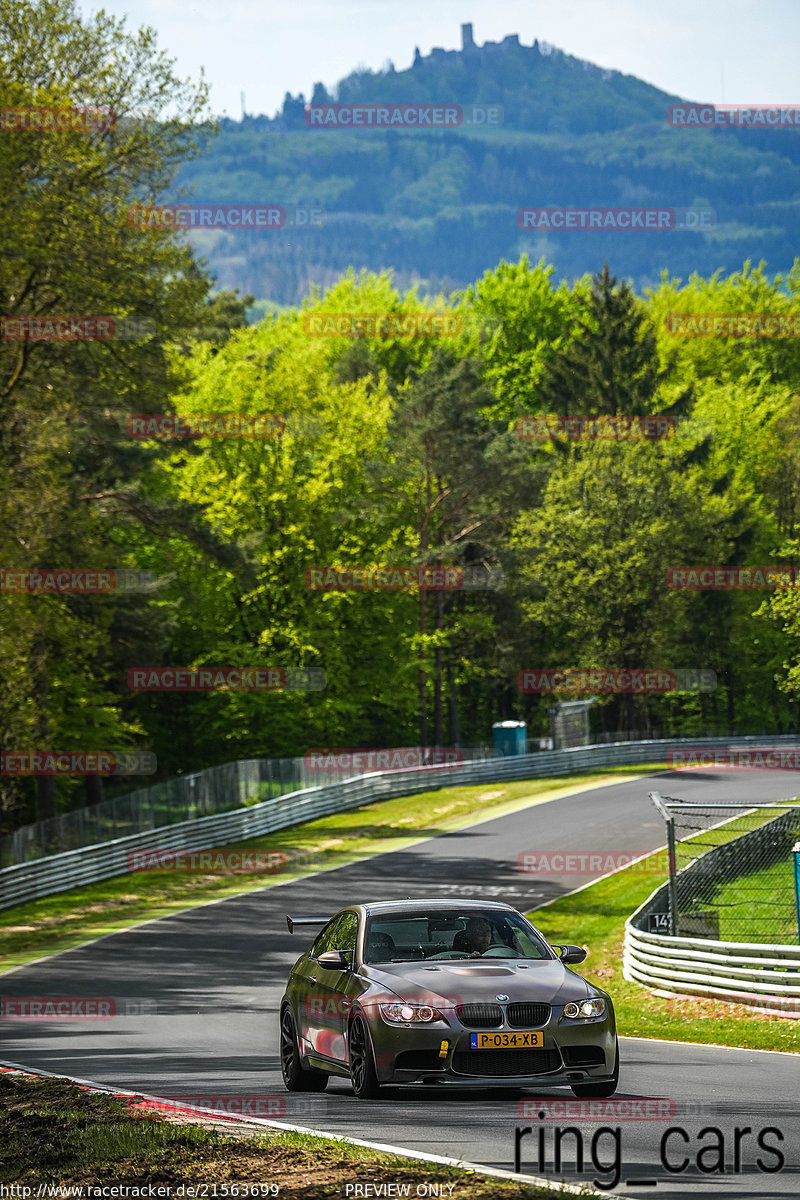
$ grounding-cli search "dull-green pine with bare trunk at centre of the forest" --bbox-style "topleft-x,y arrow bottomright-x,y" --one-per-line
373,350 -> 530,745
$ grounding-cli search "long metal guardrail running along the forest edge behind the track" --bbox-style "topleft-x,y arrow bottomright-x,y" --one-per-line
0,737 -> 800,908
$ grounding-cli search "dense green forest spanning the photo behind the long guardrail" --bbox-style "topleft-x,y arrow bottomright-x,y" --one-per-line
0,0 -> 800,832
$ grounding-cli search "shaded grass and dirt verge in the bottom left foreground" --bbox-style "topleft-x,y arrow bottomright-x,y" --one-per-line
0,1073 -> 573,1200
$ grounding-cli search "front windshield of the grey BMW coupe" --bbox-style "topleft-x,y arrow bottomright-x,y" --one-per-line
363,908 -> 553,962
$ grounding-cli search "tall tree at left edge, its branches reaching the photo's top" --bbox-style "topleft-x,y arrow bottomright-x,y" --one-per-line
0,0 -> 210,817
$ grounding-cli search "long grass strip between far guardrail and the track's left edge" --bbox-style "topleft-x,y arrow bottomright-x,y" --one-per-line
0,763 -> 666,971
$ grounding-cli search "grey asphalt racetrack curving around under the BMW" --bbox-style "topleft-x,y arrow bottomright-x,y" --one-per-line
0,772 -> 800,1200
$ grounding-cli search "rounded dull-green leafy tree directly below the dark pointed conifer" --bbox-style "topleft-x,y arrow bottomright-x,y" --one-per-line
515,443 -> 747,728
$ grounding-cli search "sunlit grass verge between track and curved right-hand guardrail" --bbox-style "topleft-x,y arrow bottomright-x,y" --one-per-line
528,830 -> 800,1052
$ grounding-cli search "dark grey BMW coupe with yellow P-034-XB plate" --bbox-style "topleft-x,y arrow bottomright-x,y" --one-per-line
281,900 -> 619,1099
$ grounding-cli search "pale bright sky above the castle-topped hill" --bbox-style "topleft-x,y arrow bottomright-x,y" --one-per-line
78,0 -> 800,119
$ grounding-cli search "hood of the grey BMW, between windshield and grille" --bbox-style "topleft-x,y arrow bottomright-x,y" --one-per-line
363,959 -> 595,1004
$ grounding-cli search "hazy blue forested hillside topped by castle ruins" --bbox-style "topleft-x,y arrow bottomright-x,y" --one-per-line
179,26 -> 800,305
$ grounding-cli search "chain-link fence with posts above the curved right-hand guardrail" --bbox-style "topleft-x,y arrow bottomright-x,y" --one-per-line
650,792 -> 800,944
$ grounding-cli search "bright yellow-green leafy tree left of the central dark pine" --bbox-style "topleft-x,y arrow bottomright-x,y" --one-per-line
136,304 -> 414,763
